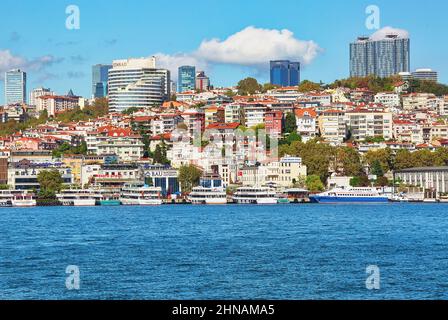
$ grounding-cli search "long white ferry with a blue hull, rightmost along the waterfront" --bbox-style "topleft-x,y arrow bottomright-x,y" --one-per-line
310,188 -> 389,203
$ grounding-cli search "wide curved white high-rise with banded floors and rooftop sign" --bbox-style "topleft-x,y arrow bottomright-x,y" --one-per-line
108,57 -> 171,112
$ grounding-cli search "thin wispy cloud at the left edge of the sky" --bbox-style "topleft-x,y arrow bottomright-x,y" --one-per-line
0,50 -> 63,79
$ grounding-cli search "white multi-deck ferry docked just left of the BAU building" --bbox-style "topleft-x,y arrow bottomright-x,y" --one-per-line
120,184 -> 162,206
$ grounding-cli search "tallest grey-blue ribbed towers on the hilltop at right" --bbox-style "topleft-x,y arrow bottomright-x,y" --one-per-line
350,34 -> 410,78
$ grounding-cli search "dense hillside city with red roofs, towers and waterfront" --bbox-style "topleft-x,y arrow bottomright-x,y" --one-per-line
0,30 -> 448,206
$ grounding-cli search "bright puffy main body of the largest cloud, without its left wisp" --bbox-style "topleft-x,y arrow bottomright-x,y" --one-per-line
196,26 -> 321,66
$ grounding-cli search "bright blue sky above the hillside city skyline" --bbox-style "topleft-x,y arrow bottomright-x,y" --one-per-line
0,0 -> 448,104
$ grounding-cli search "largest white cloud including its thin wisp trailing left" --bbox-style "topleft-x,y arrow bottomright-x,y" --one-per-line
155,26 -> 322,79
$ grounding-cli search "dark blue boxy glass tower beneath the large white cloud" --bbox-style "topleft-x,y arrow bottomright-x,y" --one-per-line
271,60 -> 300,87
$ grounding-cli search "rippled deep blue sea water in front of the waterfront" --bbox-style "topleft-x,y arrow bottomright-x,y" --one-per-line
0,204 -> 448,299
